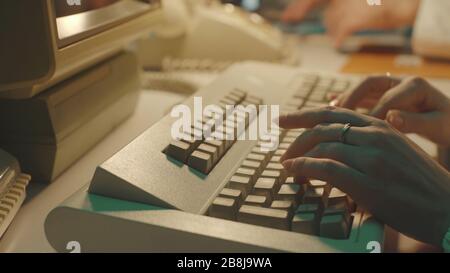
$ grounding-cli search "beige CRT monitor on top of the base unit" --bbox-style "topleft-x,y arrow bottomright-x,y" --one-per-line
0,0 -> 161,99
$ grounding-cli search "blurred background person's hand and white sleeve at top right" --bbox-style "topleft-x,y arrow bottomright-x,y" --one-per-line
281,0 -> 450,59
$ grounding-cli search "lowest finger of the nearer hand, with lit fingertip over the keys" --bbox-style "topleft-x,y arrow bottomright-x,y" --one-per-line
283,157 -> 367,196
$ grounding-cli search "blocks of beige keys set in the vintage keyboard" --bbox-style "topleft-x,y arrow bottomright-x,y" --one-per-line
164,74 -> 356,239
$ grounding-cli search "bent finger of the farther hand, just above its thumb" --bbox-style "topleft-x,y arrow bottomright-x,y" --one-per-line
371,78 -> 430,119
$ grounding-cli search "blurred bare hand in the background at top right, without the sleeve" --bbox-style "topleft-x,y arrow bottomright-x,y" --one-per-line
281,0 -> 420,47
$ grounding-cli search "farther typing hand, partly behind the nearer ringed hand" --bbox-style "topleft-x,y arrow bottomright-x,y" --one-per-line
334,76 -> 450,147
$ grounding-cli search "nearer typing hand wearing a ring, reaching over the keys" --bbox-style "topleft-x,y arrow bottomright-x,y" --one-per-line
279,107 -> 450,245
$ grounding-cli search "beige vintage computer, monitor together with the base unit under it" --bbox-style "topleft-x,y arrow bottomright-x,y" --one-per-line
0,0 -> 161,182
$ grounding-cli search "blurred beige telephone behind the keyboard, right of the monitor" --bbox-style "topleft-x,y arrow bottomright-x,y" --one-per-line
138,0 -> 298,71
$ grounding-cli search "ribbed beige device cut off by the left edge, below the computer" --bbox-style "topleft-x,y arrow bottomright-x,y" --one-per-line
0,149 -> 31,238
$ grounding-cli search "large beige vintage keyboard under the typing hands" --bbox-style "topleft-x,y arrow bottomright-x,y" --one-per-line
46,62 -> 384,252
